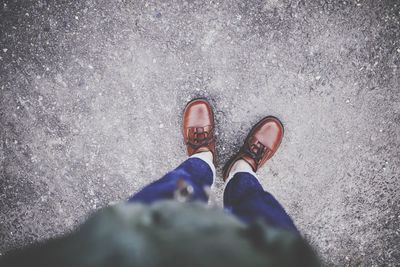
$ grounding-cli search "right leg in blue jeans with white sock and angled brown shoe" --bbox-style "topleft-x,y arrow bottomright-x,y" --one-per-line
223,117 -> 298,232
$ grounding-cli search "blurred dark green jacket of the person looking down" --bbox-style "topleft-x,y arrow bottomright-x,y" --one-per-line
0,201 -> 320,267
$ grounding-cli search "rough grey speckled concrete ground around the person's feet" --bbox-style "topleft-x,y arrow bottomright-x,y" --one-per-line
0,0 -> 400,266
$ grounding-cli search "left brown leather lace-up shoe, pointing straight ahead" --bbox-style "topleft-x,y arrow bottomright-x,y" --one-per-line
183,99 -> 215,163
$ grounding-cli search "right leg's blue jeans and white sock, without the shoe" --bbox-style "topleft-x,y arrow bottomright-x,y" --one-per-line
224,160 -> 298,233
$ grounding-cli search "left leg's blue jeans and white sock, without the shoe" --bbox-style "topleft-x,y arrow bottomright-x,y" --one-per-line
128,152 -> 215,203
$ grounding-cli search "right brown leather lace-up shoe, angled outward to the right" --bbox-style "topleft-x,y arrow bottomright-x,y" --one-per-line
223,116 -> 283,181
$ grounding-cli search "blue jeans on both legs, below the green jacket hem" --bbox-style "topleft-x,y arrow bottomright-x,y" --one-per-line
128,158 -> 298,233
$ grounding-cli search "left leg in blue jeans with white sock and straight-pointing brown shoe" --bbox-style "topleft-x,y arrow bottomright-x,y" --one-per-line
128,99 -> 215,203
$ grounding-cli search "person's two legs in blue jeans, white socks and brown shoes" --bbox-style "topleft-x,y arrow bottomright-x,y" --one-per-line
129,99 -> 297,233
